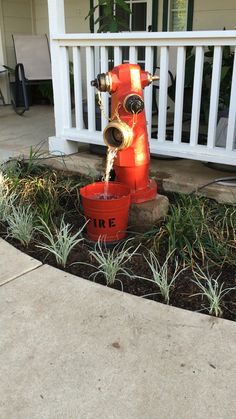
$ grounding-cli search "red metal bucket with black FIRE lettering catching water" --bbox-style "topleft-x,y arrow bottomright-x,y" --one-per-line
80,182 -> 130,242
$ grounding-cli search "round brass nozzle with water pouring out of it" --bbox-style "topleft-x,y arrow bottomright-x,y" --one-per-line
103,121 -> 133,150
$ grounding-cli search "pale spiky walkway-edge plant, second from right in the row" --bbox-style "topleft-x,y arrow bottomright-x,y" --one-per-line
138,251 -> 184,304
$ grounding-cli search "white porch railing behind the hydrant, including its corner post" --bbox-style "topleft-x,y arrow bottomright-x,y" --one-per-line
49,0 -> 236,165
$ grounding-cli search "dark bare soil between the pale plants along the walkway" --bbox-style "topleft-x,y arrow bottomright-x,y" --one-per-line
0,215 -> 236,321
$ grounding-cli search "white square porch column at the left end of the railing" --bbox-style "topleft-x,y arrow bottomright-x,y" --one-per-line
48,0 -> 78,155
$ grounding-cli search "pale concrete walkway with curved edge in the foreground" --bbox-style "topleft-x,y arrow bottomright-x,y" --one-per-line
0,240 -> 236,419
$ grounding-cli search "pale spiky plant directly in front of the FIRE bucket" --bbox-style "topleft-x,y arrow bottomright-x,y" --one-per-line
81,239 -> 139,290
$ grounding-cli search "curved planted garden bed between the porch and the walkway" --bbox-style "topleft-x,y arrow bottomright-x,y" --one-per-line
0,159 -> 236,321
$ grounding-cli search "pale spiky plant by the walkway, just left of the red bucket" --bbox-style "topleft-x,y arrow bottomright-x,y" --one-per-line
37,217 -> 87,268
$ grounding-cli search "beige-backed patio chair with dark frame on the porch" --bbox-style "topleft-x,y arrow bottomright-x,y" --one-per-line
12,35 -> 52,115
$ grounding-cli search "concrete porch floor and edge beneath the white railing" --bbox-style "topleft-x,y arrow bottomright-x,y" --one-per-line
0,106 -> 236,203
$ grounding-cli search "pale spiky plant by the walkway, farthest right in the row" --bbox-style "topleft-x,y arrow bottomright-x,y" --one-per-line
192,266 -> 236,317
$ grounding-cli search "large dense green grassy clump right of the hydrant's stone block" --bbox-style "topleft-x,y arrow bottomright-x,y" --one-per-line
152,194 -> 236,266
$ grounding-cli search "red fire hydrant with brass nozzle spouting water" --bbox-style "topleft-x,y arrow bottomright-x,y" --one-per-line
91,64 -> 157,203
